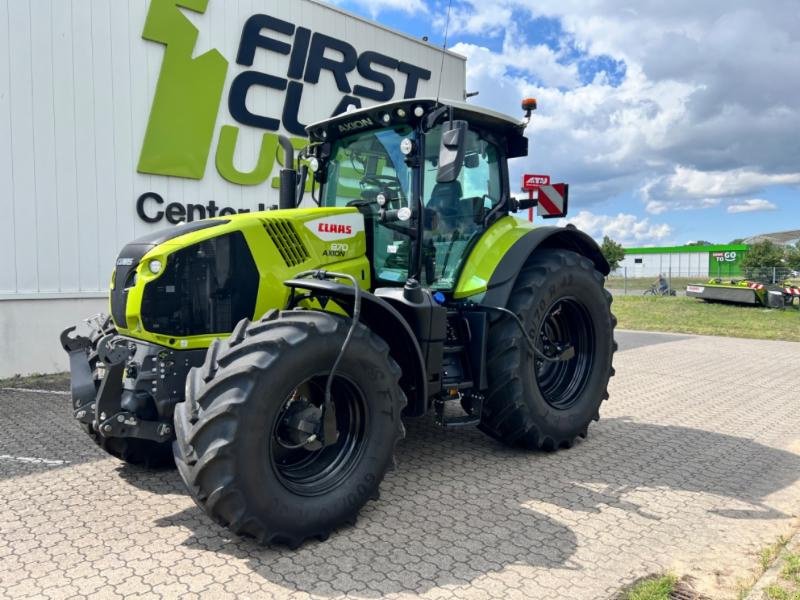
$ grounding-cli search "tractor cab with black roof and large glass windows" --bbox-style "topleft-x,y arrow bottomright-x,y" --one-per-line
308,100 -> 527,292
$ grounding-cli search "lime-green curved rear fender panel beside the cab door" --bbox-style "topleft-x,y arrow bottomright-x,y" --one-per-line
453,216 -> 534,300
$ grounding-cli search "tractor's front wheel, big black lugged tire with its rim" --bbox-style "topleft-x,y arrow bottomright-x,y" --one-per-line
174,310 -> 405,547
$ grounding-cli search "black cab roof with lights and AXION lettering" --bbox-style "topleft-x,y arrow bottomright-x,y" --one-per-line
306,98 -> 528,158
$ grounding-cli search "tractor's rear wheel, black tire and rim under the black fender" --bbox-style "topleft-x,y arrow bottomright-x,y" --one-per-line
479,249 -> 617,450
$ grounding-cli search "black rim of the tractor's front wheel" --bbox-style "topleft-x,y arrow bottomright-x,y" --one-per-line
268,374 -> 367,496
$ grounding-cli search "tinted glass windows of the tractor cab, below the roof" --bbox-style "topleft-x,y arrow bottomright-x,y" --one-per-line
322,120 -> 503,291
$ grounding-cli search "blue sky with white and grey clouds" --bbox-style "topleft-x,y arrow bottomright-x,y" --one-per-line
326,0 -> 800,246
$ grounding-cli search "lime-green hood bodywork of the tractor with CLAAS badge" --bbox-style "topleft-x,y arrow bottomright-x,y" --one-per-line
112,208 -> 371,350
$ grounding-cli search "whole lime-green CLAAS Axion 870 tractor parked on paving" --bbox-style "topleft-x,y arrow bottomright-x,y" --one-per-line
61,99 -> 616,546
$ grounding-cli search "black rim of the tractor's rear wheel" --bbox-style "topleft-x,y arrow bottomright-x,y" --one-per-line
534,298 -> 594,410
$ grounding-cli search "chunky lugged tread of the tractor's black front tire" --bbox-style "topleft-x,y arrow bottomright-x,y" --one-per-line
173,310 -> 405,548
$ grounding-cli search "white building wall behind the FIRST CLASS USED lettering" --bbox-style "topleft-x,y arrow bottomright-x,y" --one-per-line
0,0 -> 465,377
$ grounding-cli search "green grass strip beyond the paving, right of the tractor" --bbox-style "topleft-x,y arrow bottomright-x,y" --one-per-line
612,296 -> 800,342
